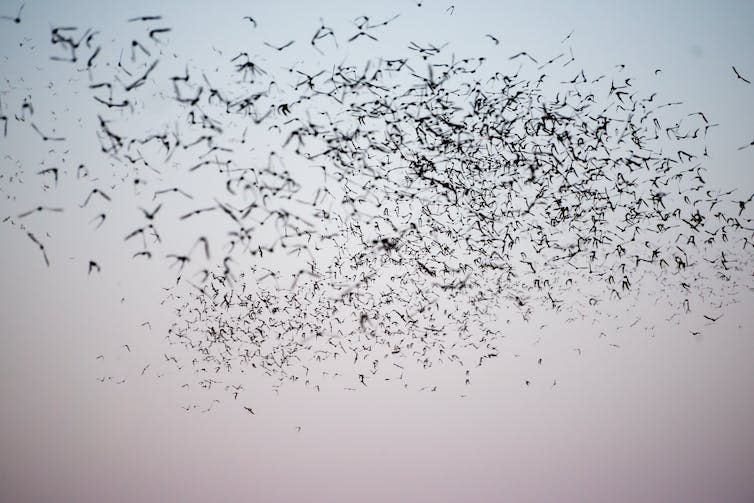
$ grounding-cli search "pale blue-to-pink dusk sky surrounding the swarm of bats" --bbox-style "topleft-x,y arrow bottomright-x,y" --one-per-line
0,0 -> 754,502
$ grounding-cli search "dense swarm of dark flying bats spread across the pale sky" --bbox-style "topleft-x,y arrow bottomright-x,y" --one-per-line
0,5 -> 754,395
